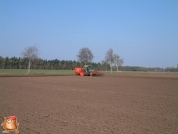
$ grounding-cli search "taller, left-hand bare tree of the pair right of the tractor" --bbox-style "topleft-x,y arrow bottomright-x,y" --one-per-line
105,48 -> 114,73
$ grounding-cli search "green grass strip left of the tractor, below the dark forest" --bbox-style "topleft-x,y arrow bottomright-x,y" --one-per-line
0,69 -> 74,76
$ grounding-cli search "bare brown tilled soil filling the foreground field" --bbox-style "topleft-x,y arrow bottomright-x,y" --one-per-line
0,75 -> 178,134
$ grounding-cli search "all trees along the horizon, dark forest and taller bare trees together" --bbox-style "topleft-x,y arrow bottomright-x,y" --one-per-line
0,46 -> 178,73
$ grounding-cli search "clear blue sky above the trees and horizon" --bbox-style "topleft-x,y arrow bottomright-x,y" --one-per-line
0,0 -> 178,68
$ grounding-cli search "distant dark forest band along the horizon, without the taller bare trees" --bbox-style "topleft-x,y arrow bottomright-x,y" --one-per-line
0,56 -> 178,72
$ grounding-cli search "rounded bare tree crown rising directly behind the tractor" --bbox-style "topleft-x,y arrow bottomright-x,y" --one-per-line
77,48 -> 94,65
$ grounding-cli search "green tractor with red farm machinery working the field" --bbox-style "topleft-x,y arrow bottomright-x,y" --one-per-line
74,65 -> 104,76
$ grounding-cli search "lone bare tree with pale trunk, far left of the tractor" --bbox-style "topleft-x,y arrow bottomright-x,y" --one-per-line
22,46 -> 38,74
